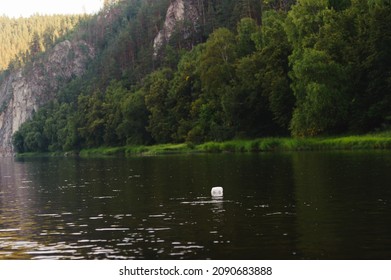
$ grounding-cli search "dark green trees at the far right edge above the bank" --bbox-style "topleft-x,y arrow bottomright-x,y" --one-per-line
349,0 -> 391,132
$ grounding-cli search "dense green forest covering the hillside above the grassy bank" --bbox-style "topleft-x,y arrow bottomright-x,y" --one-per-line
7,0 -> 391,152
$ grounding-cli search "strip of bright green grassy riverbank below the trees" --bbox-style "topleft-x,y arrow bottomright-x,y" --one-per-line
76,132 -> 391,157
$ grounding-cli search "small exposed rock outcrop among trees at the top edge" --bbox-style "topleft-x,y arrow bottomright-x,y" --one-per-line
153,0 -> 202,56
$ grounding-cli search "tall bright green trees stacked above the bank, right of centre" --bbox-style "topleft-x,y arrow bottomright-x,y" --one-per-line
286,0 -> 349,136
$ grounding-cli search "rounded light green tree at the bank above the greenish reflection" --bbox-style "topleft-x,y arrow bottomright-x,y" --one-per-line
291,49 -> 348,136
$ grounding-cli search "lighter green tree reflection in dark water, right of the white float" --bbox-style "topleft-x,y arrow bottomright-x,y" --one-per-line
292,153 -> 340,258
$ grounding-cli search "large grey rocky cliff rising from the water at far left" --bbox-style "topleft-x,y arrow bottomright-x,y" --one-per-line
0,40 -> 94,156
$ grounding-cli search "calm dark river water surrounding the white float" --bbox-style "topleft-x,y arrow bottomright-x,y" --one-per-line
0,151 -> 391,259
